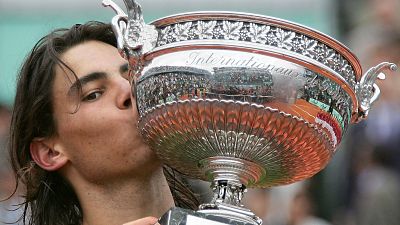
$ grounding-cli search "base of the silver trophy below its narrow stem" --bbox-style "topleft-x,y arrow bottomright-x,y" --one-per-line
158,207 -> 262,225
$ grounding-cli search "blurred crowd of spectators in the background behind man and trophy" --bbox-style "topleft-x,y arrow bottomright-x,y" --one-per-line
0,0 -> 400,225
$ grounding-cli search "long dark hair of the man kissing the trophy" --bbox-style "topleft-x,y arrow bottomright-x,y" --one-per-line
9,22 -> 198,225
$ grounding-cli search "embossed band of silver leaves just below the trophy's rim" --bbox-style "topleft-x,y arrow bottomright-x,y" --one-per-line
157,20 -> 356,87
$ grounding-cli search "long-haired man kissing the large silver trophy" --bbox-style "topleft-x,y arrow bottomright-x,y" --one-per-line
10,22 -> 198,225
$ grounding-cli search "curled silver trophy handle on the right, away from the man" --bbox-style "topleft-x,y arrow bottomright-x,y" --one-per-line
356,62 -> 397,121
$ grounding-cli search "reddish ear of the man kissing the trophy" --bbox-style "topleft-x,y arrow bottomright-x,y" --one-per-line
30,138 -> 68,171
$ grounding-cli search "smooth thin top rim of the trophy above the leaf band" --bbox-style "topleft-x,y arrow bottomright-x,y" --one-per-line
150,11 -> 362,82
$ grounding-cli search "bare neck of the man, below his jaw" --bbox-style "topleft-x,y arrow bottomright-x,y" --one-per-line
78,168 -> 174,225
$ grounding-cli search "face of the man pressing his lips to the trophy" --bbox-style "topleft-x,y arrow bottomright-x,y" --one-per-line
53,41 -> 160,183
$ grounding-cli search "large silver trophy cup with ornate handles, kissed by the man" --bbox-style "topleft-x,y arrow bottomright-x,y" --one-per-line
103,0 -> 396,225
